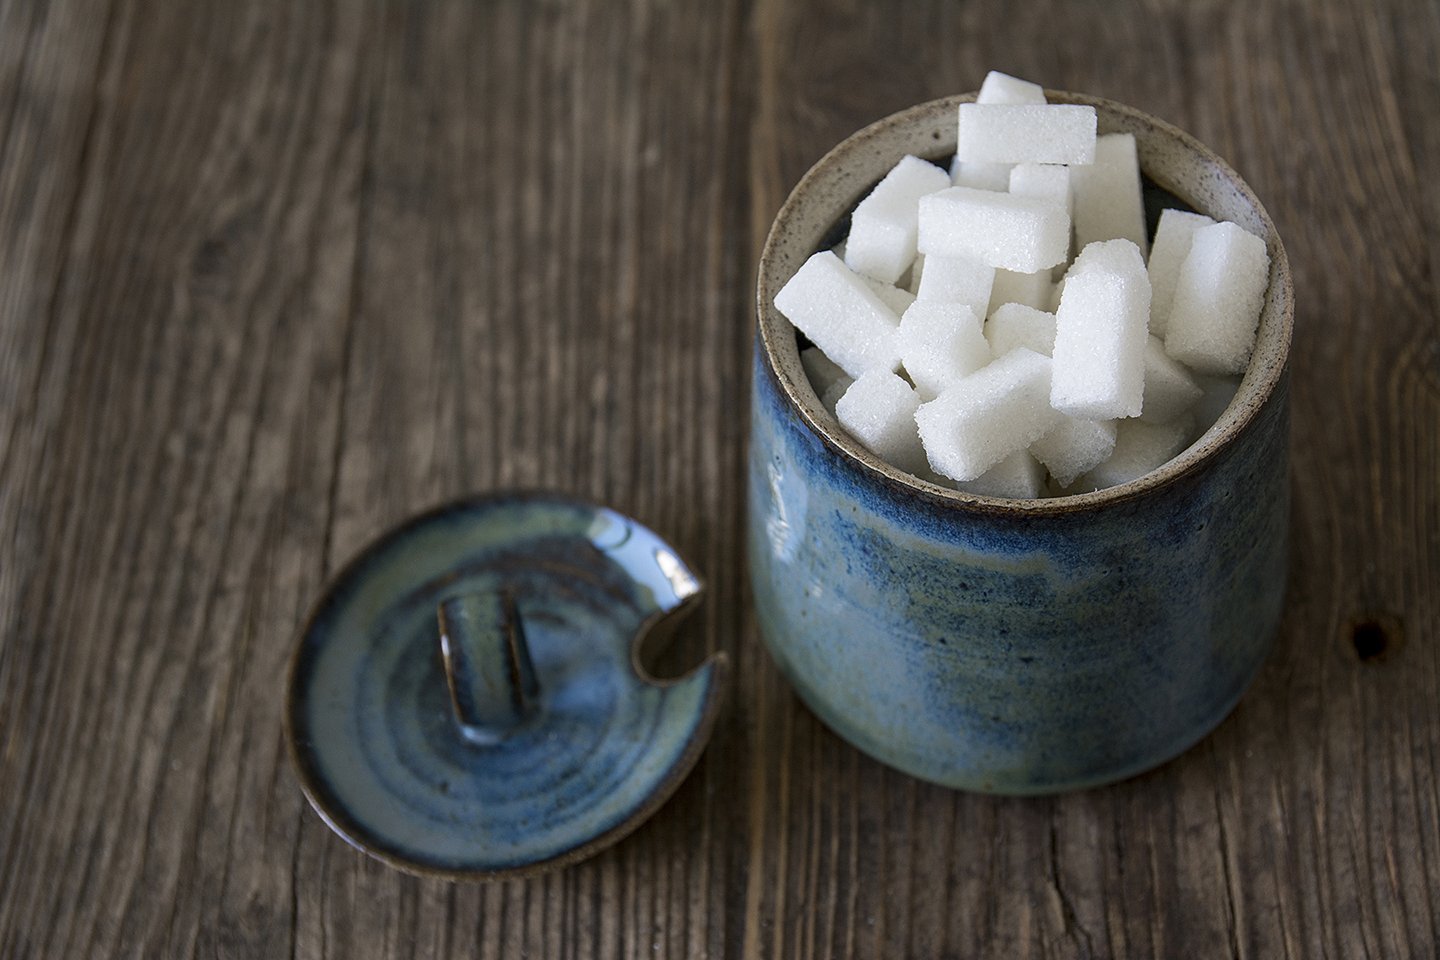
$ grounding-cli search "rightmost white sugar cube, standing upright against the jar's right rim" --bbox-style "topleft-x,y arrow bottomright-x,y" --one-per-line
1169,223 -> 1270,373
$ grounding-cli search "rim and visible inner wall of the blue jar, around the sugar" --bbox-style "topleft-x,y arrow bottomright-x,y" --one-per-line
756,91 -> 1293,512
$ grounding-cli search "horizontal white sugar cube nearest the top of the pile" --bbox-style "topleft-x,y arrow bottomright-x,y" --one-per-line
955,104 -> 1096,164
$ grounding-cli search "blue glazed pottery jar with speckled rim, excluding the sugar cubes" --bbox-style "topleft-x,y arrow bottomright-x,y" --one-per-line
749,92 -> 1293,794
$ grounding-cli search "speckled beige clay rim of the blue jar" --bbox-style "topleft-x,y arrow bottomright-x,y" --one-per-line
756,89 -> 1295,515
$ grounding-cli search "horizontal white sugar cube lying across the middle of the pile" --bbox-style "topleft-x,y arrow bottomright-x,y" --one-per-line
919,187 -> 1070,273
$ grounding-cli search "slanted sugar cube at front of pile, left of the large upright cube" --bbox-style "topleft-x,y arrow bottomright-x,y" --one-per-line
914,347 -> 1060,481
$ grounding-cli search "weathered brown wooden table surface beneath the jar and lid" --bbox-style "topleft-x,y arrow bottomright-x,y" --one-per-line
0,0 -> 1440,960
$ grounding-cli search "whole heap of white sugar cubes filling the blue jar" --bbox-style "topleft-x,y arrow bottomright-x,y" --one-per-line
775,72 -> 1270,498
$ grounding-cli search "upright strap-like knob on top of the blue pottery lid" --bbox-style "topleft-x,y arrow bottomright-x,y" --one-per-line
438,590 -> 540,746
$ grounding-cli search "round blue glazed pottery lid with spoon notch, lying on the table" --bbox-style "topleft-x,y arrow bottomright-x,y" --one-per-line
285,492 -> 726,879
